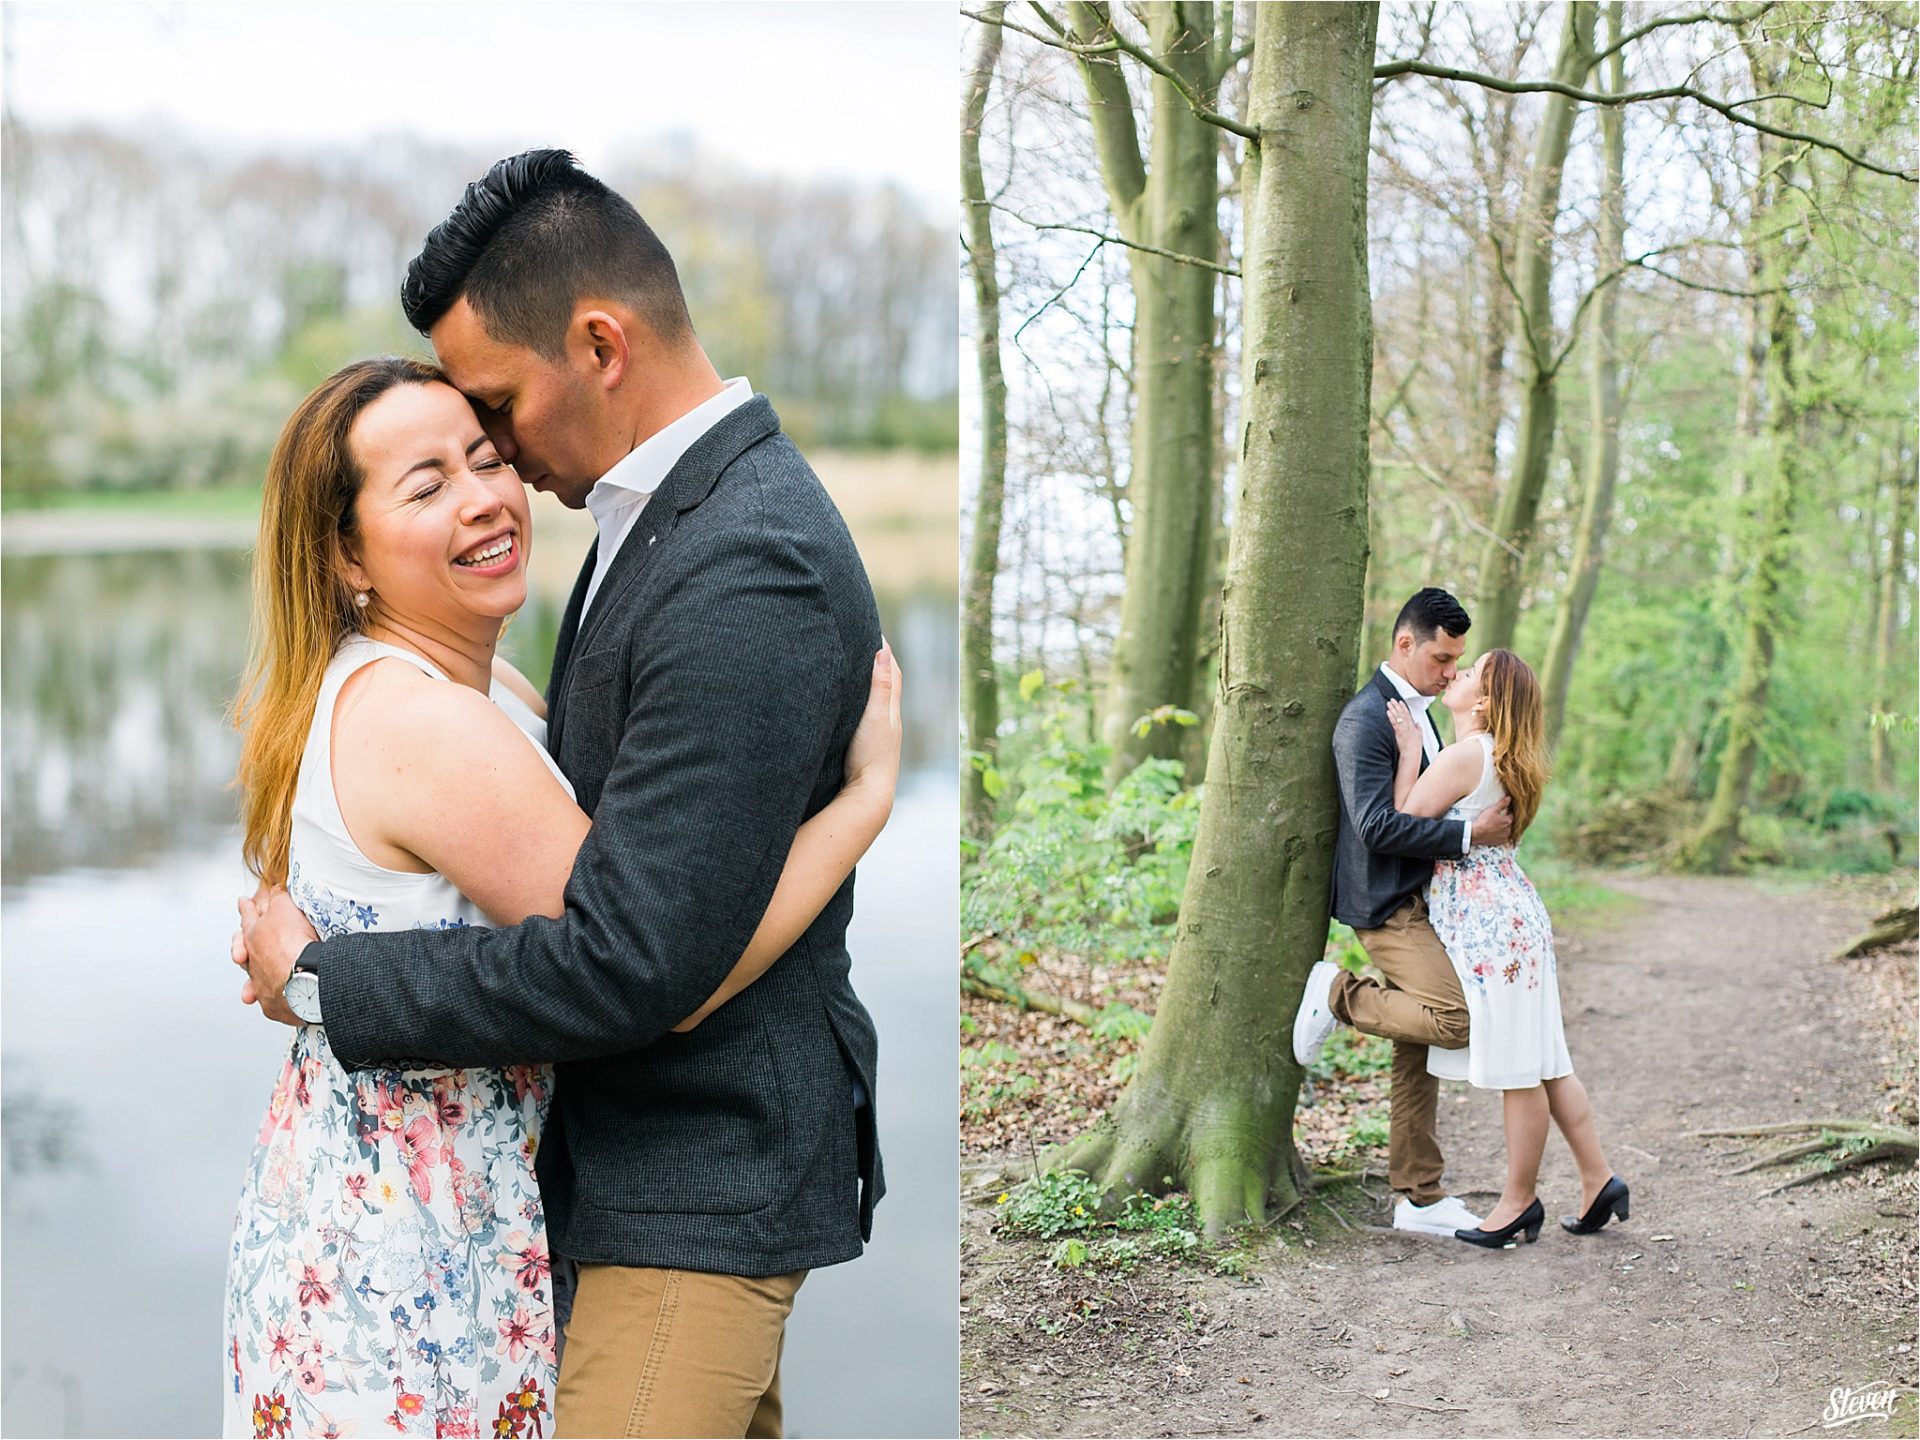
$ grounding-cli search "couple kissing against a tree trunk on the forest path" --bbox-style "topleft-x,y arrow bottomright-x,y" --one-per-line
1294,588 -> 1628,1248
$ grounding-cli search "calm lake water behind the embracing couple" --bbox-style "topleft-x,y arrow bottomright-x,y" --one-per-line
0,549 -> 958,1436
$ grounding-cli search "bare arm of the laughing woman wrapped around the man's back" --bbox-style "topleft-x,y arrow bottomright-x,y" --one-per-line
334,649 -> 900,1031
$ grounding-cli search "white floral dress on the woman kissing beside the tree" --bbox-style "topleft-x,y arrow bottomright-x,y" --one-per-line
1427,733 -> 1572,1091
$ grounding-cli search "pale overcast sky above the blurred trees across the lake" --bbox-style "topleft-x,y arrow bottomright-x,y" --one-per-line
4,0 -> 960,215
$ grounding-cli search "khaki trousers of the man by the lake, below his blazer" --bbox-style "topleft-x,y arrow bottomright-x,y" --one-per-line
553,1265 -> 806,1436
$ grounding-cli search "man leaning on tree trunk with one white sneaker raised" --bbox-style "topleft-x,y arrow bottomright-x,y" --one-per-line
1294,589 -> 1513,1235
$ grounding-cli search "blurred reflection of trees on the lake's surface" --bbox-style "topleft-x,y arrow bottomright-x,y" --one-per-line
0,551 -> 958,887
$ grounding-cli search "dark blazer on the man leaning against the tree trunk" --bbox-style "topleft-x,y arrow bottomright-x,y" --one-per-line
1332,670 -> 1467,929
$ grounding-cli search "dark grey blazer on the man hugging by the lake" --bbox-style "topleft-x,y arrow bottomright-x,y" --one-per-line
315,396 -> 885,1275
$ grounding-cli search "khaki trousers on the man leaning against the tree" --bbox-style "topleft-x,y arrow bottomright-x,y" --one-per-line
1329,895 -> 1467,1206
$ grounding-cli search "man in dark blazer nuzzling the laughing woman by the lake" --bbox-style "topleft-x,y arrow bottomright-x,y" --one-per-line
246,150 -> 883,1434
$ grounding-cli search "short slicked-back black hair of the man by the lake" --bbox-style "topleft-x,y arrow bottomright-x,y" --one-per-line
399,150 -> 693,359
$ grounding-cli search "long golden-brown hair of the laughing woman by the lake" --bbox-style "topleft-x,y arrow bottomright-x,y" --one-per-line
232,355 -> 445,885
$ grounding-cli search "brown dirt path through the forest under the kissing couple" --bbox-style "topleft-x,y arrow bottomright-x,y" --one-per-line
962,877 -> 1920,1436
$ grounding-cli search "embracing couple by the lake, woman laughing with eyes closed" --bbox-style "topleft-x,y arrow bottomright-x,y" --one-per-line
225,150 -> 900,1436
